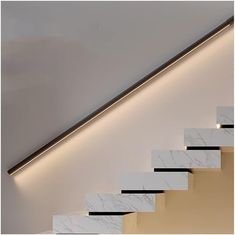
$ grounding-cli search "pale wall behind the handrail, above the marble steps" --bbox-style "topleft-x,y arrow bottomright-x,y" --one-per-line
2,2 -> 233,233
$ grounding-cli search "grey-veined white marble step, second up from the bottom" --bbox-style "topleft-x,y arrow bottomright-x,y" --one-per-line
86,193 -> 155,212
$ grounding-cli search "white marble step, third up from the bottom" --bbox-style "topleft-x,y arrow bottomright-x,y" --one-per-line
121,172 -> 190,191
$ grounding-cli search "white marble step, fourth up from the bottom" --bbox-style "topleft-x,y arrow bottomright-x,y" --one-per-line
151,150 -> 221,169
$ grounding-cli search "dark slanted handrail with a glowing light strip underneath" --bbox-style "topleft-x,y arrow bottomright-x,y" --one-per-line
7,16 -> 234,175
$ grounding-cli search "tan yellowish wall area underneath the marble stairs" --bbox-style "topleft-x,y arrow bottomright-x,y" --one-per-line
124,153 -> 234,234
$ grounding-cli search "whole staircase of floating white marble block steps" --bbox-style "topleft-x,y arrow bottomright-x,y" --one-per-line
53,107 -> 234,234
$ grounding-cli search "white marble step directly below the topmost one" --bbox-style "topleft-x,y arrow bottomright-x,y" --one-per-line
184,128 -> 234,147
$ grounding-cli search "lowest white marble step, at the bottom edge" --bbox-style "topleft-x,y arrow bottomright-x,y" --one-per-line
53,215 -> 123,234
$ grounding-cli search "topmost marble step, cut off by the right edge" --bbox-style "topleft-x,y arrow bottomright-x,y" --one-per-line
216,106 -> 234,125
